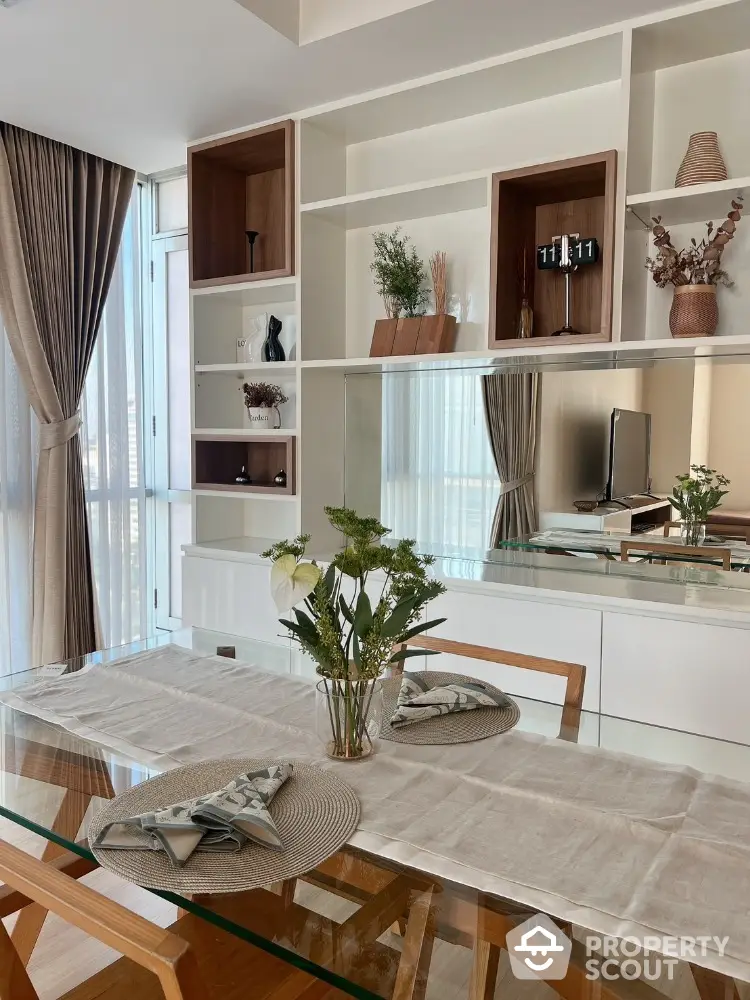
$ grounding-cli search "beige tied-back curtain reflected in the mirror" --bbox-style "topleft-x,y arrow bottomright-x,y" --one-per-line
482,372 -> 539,548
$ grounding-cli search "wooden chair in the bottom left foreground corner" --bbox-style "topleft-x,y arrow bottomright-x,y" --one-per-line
0,841 -> 356,1000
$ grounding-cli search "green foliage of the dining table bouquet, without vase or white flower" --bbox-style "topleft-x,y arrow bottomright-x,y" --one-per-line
263,507 -> 445,680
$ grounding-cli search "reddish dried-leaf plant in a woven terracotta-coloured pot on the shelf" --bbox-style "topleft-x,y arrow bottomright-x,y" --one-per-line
646,197 -> 742,337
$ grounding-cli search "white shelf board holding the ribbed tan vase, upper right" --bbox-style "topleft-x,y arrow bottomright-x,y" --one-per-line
626,177 -> 750,228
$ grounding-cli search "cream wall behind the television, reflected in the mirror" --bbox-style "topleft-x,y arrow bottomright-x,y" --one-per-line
536,368 -> 643,511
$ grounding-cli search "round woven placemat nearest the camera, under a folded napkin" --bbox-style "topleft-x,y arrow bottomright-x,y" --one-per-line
88,758 -> 359,893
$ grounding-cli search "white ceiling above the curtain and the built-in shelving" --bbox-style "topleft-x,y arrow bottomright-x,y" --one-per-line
0,0 -> 692,172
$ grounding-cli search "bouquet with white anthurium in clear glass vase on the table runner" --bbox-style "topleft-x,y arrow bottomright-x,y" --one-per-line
263,507 -> 445,760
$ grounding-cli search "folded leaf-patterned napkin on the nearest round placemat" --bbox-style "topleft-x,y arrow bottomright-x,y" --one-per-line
94,764 -> 294,868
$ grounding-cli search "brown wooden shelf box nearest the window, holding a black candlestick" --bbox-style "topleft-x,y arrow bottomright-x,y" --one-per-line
188,121 -> 294,288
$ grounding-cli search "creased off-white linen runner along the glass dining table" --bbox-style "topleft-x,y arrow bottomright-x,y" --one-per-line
0,647 -> 750,981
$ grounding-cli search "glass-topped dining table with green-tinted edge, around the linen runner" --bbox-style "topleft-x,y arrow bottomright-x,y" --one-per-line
0,629 -> 750,1000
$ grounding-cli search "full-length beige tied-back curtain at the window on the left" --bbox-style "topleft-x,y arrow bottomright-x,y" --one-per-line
0,122 -> 135,664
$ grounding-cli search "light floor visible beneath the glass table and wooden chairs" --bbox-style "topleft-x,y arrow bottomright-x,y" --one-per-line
0,775 -> 716,1000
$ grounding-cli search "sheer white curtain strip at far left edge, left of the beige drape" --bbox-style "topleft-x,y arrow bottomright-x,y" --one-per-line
0,320 -> 36,675
